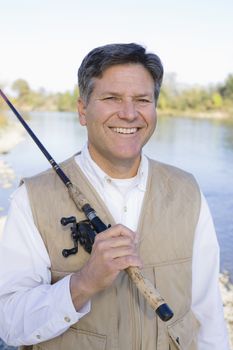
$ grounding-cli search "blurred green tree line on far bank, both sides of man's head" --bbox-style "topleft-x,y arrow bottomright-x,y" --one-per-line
0,73 -> 233,114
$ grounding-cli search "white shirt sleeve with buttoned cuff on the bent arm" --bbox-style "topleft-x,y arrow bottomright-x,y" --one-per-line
0,185 -> 90,346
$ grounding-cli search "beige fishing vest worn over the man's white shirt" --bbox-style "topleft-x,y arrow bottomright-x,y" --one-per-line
21,157 -> 200,350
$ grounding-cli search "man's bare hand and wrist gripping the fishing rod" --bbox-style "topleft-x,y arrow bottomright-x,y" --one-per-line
70,225 -> 142,311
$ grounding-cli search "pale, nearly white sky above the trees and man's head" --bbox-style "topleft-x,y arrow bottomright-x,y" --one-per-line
0,0 -> 233,92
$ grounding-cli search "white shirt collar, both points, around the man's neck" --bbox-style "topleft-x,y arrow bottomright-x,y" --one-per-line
75,143 -> 149,192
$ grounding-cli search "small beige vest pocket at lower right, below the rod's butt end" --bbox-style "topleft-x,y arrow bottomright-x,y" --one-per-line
168,310 -> 199,350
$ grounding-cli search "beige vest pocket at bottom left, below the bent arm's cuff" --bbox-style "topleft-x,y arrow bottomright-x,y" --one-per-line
33,328 -> 107,350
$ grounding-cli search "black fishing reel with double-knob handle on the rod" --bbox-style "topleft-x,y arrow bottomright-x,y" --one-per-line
61,216 -> 96,258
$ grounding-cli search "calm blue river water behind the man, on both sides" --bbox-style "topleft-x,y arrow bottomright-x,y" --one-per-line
0,112 -> 233,348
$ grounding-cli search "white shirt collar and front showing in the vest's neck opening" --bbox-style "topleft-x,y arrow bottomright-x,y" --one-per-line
78,145 -> 148,231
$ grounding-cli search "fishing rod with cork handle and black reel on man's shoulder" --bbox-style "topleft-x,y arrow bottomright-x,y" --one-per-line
0,89 -> 173,321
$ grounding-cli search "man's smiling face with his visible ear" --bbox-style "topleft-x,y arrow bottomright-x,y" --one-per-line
78,64 -> 157,176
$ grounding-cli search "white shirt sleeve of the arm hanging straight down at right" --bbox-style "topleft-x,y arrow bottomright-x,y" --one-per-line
192,194 -> 229,350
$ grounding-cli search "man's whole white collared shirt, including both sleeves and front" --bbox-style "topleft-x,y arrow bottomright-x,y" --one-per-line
0,146 -> 229,350
